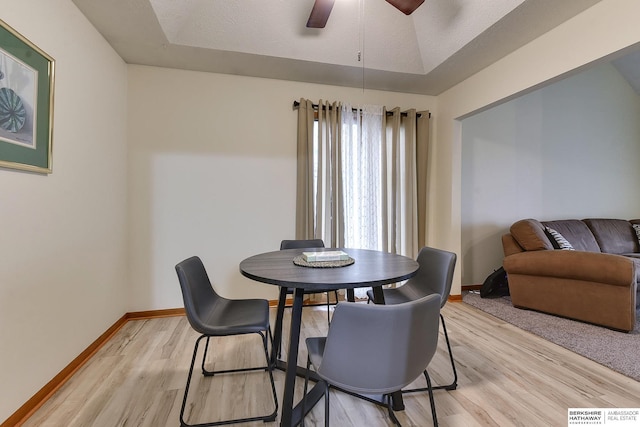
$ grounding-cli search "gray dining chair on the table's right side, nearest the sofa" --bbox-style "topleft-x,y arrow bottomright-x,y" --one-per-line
367,246 -> 458,393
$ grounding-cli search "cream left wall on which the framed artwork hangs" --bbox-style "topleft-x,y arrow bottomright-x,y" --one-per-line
0,0 -> 127,421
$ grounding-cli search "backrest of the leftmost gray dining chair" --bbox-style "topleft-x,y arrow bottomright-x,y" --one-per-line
176,256 -> 225,334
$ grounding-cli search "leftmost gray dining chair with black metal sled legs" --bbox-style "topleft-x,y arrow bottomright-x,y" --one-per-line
176,256 -> 278,427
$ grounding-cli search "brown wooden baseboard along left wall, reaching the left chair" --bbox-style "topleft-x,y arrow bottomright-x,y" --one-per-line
0,308 -> 185,427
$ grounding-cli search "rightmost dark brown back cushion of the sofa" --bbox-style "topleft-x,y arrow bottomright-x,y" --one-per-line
583,218 -> 639,254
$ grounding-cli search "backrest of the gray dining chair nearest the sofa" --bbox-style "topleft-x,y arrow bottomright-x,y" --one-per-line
402,246 -> 457,307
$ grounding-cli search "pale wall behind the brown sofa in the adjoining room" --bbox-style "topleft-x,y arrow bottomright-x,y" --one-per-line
462,63 -> 640,284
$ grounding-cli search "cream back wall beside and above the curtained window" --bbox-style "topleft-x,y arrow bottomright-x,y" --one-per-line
128,66 -> 435,311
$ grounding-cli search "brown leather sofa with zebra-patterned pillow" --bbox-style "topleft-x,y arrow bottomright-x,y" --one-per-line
502,218 -> 640,332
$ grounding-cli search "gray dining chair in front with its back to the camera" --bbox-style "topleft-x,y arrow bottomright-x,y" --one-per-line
302,294 -> 440,426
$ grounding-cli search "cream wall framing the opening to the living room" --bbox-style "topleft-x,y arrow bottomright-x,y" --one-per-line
428,0 -> 640,295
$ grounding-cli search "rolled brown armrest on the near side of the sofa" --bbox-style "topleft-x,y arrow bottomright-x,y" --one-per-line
503,250 -> 636,287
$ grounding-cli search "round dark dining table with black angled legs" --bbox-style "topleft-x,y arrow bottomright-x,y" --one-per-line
240,248 -> 419,426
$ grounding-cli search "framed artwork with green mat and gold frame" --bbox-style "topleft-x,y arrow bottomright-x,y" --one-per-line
0,20 -> 55,173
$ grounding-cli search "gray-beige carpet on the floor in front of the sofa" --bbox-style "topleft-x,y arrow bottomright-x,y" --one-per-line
462,293 -> 640,381
